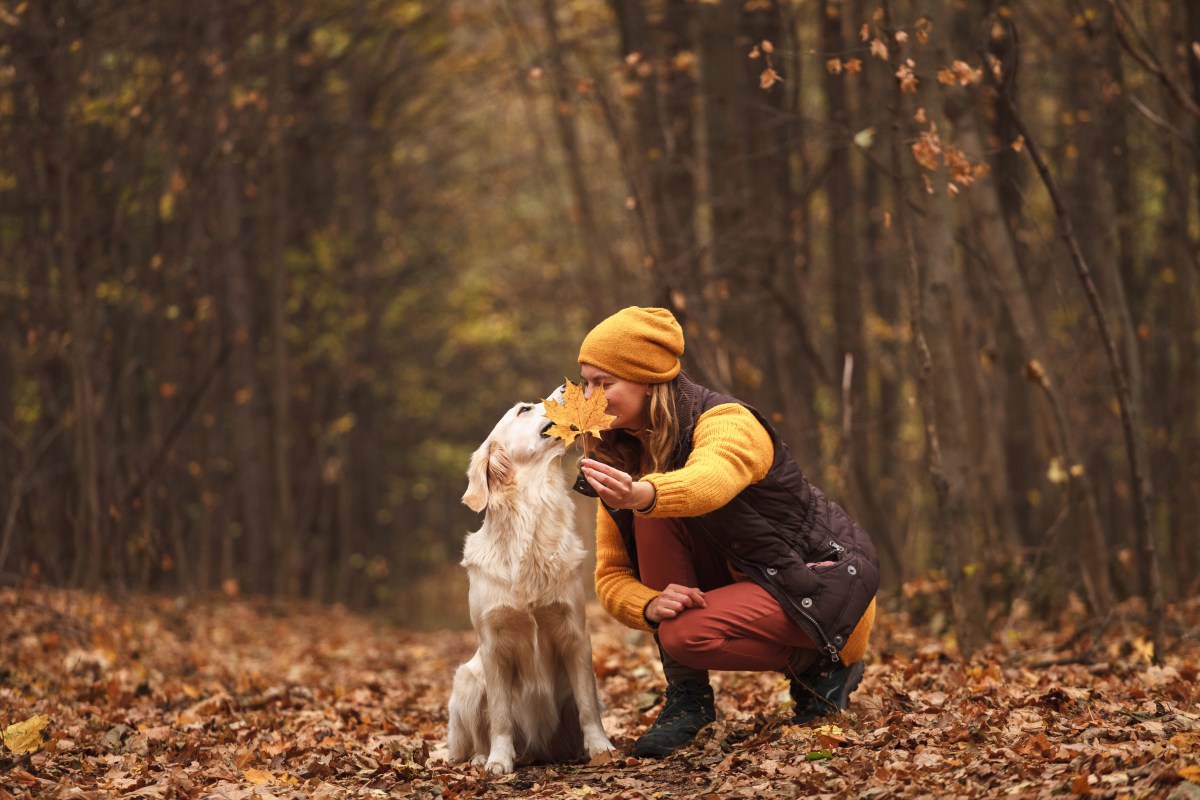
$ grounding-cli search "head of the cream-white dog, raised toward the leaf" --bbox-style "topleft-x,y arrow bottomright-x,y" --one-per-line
462,403 -> 565,511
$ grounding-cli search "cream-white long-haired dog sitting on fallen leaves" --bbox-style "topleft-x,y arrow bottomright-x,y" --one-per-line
448,403 -> 613,775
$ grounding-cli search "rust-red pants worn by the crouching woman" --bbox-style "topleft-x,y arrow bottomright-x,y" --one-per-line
634,517 -> 817,679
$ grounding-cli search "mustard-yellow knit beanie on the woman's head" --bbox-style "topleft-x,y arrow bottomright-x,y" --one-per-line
580,306 -> 683,384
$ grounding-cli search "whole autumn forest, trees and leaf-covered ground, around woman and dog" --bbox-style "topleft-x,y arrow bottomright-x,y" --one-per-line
0,0 -> 1200,800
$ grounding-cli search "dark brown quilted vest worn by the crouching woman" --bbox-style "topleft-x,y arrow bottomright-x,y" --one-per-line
608,374 -> 880,661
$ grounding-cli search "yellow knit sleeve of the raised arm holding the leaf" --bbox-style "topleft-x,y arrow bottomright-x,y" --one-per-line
642,403 -> 775,517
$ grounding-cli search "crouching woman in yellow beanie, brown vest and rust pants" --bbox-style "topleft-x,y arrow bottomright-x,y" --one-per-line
577,307 -> 878,758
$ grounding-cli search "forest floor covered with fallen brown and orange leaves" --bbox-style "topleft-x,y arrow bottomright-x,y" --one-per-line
0,589 -> 1200,800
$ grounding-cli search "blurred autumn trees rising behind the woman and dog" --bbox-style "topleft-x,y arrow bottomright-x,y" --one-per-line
0,0 -> 1200,645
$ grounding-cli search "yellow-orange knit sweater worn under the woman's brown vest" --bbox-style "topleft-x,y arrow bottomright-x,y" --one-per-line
595,403 -> 875,663
